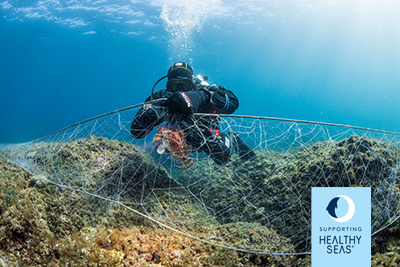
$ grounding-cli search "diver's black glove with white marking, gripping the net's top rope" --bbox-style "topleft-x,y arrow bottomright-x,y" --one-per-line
161,91 -> 209,115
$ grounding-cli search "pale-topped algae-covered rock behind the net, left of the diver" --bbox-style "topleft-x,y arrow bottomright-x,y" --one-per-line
8,136 -> 178,202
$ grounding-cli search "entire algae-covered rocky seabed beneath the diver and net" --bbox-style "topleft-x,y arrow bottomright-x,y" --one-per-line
0,136 -> 400,266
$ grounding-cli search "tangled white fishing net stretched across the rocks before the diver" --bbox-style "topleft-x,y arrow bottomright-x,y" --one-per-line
1,103 -> 400,254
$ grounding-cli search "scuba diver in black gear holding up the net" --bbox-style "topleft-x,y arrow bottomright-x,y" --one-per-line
131,62 -> 256,165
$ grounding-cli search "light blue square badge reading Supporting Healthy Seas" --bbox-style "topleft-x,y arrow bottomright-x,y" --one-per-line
311,187 -> 371,267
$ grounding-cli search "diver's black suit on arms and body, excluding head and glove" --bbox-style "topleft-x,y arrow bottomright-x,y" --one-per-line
131,85 -> 239,165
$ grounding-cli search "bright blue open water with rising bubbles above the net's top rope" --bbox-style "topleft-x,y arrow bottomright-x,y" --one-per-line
0,0 -> 400,143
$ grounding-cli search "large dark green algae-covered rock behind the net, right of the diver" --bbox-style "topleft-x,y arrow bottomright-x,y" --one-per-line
179,136 -> 400,252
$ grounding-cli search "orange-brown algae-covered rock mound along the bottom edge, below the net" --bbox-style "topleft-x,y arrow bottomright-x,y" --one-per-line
51,225 -> 296,267
